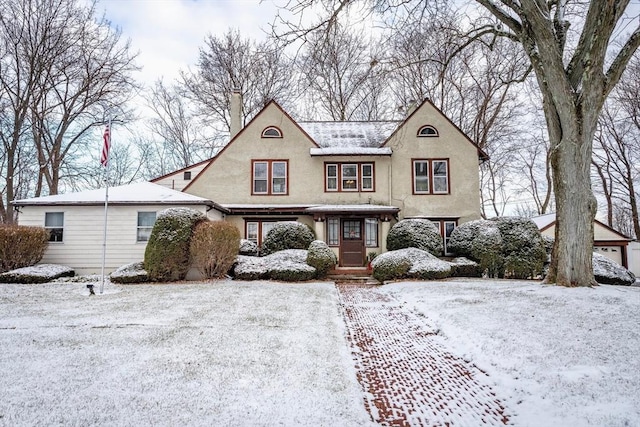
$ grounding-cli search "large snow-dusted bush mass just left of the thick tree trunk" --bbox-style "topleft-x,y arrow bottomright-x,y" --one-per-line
449,217 -> 547,279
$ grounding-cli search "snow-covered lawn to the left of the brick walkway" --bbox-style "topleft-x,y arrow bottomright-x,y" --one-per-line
0,282 -> 370,426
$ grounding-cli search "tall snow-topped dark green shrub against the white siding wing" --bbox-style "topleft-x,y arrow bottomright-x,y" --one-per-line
144,208 -> 206,282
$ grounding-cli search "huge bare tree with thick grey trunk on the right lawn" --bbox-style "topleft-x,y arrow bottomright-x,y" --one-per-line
274,0 -> 640,286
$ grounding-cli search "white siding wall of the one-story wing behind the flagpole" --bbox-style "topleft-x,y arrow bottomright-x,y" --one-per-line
18,205 -> 222,274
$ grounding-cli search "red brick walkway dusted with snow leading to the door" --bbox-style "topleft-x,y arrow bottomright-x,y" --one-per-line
336,284 -> 510,426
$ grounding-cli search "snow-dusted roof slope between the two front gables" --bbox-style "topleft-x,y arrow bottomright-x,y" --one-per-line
298,121 -> 400,150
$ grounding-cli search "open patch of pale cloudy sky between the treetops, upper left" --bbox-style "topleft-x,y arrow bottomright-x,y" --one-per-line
98,0 -> 277,84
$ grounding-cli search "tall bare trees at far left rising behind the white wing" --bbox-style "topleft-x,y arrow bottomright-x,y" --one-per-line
0,0 -> 135,222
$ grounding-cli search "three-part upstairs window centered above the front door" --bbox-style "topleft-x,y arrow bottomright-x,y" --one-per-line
325,163 -> 374,191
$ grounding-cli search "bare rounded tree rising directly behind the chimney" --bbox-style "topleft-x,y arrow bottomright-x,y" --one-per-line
181,30 -> 293,133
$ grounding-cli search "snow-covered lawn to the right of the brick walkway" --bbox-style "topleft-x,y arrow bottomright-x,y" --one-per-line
386,279 -> 640,427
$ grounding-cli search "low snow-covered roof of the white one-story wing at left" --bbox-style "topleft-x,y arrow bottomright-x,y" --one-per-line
12,182 -> 227,212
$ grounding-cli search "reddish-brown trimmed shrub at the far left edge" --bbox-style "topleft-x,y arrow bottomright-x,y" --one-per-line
0,225 -> 49,273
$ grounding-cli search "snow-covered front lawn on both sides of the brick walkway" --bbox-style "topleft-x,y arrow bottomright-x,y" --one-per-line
0,279 -> 640,427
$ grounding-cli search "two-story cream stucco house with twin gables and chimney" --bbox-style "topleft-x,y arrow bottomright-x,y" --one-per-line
152,97 -> 487,267
